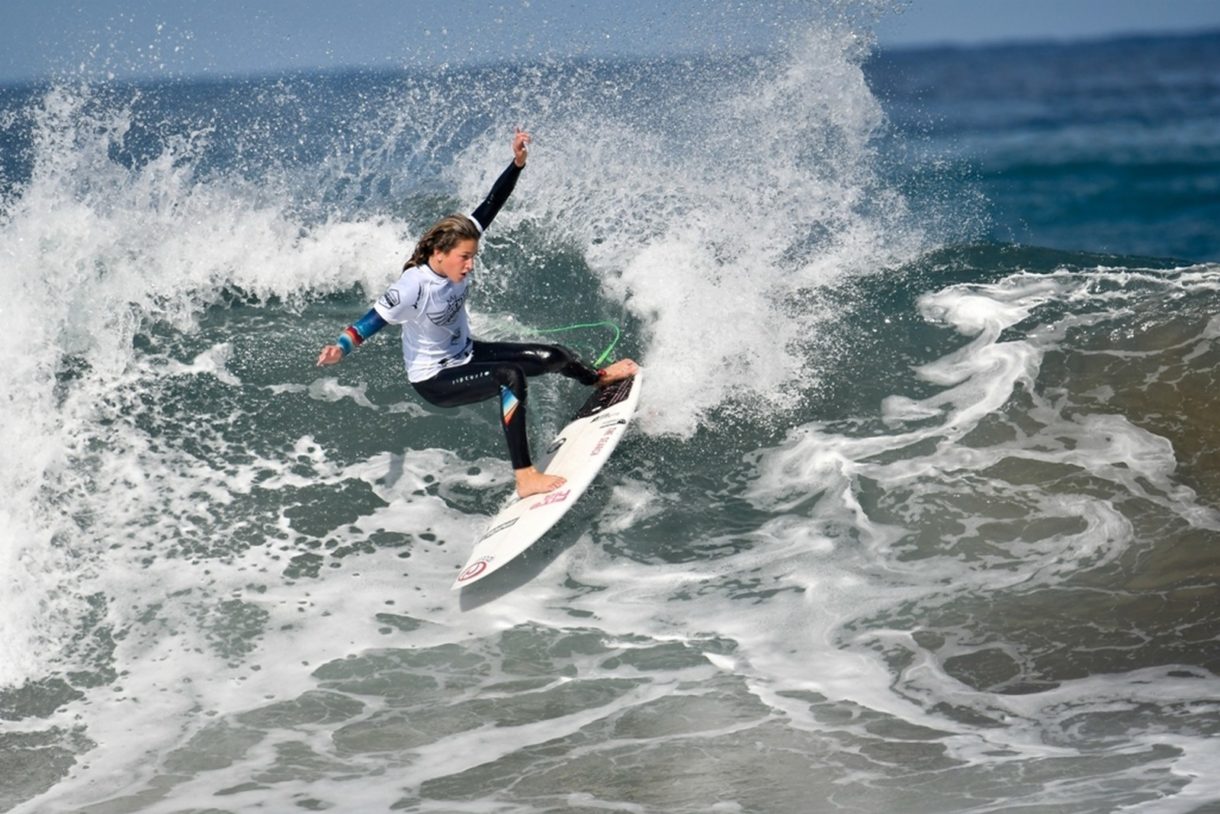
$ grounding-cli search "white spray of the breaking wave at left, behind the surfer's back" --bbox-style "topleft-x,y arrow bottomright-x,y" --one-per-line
0,85 -> 400,685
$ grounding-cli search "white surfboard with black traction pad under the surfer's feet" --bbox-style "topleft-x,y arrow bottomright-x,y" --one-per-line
453,373 -> 641,589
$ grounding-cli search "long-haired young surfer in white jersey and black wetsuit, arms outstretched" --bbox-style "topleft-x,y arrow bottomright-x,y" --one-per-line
317,129 -> 639,497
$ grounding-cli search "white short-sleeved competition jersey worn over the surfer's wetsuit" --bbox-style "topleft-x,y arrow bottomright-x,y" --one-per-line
373,265 -> 473,382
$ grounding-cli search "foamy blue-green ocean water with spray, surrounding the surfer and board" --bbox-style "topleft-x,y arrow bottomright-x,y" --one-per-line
0,11 -> 1220,814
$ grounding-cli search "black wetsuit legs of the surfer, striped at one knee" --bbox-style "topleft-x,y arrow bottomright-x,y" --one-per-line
415,342 -> 598,469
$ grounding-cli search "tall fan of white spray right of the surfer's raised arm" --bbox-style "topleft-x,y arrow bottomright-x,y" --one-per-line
458,28 -> 925,437
